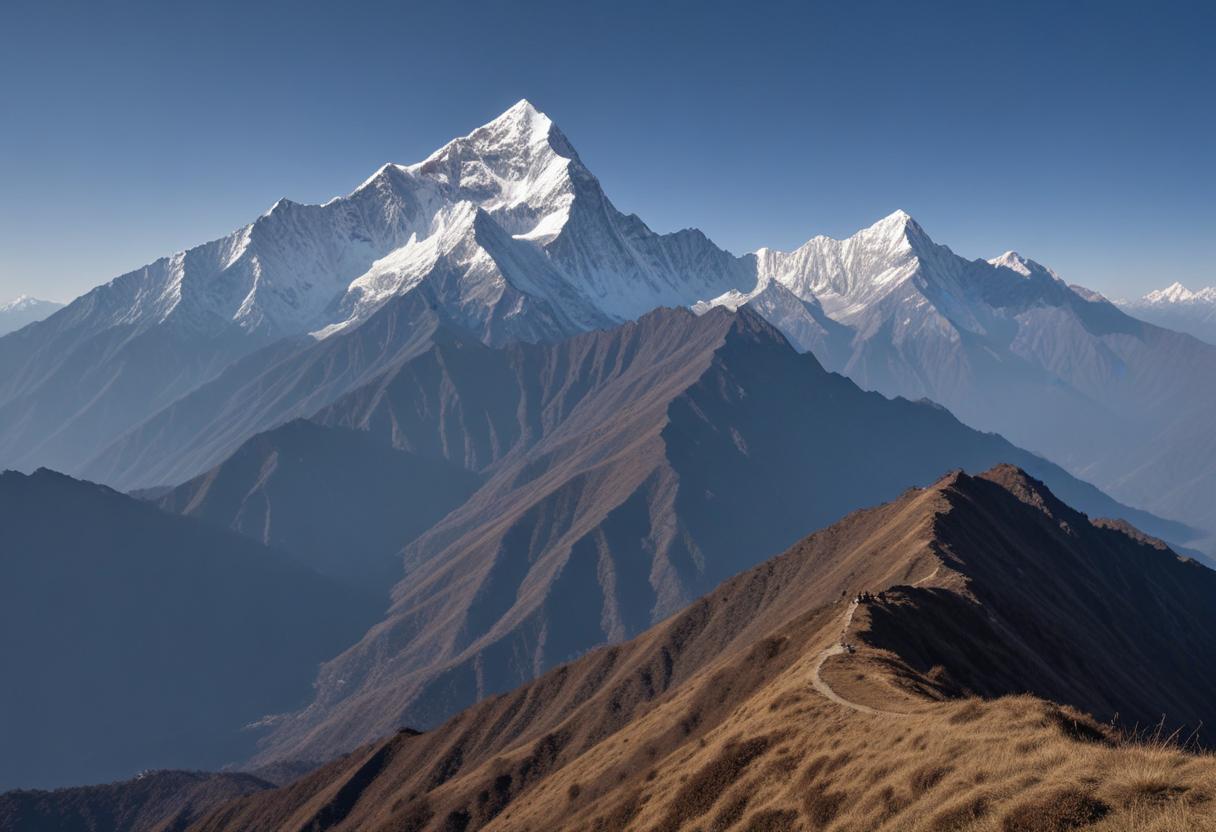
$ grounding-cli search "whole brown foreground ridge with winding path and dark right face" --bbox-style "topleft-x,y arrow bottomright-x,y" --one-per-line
177,466 -> 1216,832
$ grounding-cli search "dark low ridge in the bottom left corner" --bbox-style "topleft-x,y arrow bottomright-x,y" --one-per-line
0,771 -> 274,832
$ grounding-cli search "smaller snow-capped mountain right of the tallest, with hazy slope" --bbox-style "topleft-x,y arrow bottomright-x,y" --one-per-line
703,212 -> 1216,549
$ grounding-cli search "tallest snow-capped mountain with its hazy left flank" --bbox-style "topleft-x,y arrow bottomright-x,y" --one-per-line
0,101 -> 755,484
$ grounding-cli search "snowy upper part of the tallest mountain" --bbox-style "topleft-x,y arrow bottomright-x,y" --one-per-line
38,101 -> 748,345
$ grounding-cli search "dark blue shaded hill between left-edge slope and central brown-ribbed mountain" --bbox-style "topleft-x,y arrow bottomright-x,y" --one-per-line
154,421 -> 480,594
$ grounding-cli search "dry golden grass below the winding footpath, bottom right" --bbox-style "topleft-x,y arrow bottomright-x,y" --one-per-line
489,665 -> 1216,832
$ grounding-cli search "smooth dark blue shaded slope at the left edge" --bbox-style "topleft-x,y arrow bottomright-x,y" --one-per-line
0,471 -> 379,788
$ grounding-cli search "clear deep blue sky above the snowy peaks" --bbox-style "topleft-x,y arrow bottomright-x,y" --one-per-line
0,0 -> 1216,299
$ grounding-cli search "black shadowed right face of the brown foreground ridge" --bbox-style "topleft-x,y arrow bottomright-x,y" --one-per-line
857,466 -> 1216,743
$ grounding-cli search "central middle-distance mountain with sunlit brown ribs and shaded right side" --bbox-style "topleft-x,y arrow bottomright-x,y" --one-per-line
251,309 -> 1177,759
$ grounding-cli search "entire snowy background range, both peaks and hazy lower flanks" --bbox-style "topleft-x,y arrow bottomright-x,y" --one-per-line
0,101 -> 1216,547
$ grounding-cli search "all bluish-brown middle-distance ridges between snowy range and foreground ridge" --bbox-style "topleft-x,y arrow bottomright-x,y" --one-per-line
0,307 -> 1186,787
